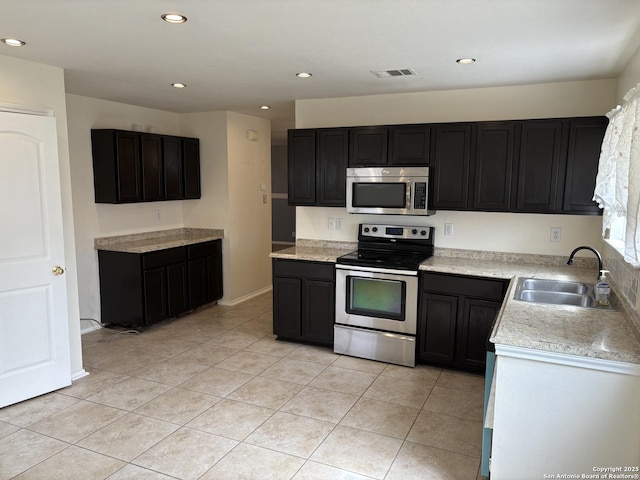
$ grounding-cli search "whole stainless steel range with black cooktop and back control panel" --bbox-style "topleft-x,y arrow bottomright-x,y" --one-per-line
333,224 -> 434,367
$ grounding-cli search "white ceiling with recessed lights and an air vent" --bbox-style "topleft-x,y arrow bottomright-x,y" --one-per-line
0,0 -> 640,142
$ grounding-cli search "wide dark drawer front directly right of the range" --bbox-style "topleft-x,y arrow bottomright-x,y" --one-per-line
422,273 -> 505,301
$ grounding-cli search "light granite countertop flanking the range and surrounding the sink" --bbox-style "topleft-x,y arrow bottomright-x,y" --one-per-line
271,241 -> 640,364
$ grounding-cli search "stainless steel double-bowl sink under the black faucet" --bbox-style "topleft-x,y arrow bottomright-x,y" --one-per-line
514,278 -> 597,308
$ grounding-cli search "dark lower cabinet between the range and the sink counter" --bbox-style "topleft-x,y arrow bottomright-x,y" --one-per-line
417,273 -> 508,373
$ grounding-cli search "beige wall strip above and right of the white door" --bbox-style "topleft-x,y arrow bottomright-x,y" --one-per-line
0,56 -> 83,377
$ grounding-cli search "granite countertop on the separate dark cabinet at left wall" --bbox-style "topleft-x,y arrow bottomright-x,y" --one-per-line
94,228 -> 224,253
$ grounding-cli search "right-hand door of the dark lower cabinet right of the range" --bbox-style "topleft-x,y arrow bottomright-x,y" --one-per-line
456,298 -> 501,372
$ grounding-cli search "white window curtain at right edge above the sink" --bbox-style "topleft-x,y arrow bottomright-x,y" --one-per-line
593,83 -> 640,266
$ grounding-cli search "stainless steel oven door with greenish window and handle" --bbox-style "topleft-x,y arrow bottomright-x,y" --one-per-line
336,264 -> 418,335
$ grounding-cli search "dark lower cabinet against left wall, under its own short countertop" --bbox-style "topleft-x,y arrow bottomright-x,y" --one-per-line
98,240 -> 222,328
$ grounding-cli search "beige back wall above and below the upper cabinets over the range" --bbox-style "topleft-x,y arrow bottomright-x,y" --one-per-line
296,79 -> 617,255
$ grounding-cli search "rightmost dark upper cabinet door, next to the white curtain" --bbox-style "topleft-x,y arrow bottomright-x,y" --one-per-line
562,117 -> 608,215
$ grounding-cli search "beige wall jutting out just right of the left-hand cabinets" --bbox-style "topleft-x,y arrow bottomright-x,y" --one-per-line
181,112 -> 271,305
